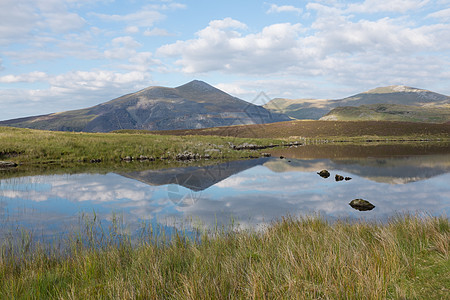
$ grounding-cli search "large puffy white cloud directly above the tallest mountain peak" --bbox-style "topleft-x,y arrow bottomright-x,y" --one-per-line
157,18 -> 301,73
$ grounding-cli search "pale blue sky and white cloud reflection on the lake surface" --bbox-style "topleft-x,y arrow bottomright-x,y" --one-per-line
0,156 -> 450,237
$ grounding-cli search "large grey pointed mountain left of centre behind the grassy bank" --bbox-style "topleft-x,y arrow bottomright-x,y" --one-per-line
0,80 -> 289,132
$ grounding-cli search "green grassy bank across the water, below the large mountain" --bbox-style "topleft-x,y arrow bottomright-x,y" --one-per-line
0,127 -> 279,163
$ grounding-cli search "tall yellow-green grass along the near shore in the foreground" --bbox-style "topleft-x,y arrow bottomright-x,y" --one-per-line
0,216 -> 450,299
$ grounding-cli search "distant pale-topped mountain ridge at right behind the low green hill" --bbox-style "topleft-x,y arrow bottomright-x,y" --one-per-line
264,85 -> 450,122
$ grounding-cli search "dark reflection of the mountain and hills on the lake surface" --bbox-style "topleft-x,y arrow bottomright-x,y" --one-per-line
118,154 -> 450,192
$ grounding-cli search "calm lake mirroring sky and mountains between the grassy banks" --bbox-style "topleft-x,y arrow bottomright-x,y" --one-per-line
0,145 -> 450,238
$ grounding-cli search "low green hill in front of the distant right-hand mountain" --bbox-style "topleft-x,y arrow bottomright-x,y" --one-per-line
320,104 -> 450,123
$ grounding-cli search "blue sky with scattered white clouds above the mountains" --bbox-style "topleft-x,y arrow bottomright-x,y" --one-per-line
0,0 -> 450,120
